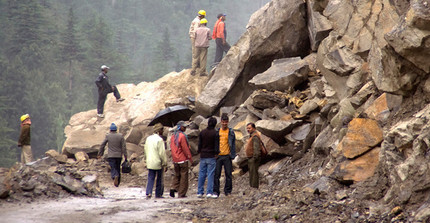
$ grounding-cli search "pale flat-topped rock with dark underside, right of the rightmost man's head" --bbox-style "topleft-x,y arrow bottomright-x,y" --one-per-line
255,120 -> 302,145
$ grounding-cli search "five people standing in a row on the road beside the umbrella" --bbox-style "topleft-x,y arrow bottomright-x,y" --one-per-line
145,114 -> 263,198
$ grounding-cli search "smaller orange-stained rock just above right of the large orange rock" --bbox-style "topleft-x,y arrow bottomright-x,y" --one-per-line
364,93 -> 403,122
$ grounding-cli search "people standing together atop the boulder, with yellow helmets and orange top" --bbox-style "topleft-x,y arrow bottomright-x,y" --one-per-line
189,10 -> 230,76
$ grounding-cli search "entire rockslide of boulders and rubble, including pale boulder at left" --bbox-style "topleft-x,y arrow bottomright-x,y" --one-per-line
3,0 -> 430,222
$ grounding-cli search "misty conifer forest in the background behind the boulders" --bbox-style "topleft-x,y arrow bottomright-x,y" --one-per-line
0,0 -> 268,167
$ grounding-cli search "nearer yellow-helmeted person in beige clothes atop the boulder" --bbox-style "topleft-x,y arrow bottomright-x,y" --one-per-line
191,19 -> 211,76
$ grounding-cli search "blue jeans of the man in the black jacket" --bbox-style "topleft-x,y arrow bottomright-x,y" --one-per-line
197,158 -> 216,194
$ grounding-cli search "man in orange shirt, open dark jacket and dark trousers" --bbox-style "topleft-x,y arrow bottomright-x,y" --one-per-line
214,114 -> 236,196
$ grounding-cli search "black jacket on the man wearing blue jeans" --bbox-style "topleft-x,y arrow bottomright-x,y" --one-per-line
197,128 -> 219,158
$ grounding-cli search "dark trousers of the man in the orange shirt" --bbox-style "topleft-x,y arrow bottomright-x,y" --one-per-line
214,155 -> 233,195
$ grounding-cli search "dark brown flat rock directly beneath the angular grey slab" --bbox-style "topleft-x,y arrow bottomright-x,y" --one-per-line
250,91 -> 285,110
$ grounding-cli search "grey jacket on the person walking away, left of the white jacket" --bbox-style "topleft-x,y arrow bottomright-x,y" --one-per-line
98,132 -> 127,159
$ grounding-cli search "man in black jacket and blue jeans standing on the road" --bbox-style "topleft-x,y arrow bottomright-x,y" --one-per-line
197,117 -> 219,198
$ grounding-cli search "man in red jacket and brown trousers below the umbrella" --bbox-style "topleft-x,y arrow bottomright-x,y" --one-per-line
170,121 -> 193,198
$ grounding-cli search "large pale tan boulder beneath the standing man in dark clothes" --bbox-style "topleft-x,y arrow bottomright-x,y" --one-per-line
62,70 -> 207,157
